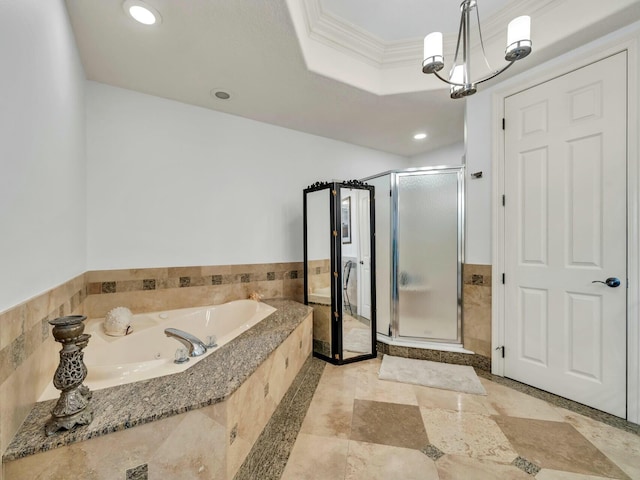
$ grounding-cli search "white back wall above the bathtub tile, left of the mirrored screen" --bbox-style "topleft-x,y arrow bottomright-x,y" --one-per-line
86,82 -> 406,270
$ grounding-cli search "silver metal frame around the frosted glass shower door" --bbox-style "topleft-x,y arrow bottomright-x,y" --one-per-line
362,165 -> 465,347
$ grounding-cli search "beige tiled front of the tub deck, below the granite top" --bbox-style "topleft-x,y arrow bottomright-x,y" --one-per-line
4,315 -> 312,480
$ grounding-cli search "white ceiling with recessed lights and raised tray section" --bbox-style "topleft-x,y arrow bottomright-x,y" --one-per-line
66,0 -> 640,156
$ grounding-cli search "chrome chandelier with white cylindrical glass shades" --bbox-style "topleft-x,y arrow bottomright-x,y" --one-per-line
422,0 -> 531,98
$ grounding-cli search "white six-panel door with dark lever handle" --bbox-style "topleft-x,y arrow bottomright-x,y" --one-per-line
505,53 -> 627,417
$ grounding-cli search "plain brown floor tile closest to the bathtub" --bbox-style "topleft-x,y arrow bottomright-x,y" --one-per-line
351,399 -> 429,450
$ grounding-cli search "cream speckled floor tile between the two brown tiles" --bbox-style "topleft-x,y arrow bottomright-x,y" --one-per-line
420,407 -> 518,463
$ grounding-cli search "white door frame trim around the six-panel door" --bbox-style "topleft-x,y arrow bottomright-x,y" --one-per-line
491,31 -> 640,423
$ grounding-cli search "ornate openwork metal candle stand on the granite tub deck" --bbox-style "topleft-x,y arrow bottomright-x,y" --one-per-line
44,315 -> 93,436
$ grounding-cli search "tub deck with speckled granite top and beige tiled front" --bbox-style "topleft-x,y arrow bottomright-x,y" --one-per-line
2,300 -> 312,480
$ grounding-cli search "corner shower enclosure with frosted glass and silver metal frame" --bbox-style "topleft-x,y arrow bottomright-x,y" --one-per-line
365,167 -> 464,348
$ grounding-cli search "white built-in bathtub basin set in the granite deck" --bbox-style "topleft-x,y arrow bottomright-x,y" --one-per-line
39,300 -> 276,401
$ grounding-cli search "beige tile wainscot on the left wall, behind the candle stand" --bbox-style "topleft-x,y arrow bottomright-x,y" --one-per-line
0,274 -> 86,458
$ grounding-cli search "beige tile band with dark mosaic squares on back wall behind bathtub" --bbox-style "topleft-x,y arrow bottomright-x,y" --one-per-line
86,262 -> 304,318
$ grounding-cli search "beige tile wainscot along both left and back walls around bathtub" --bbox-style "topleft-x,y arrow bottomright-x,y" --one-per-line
0,262 -> 304,462
